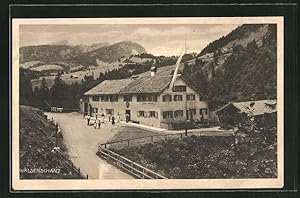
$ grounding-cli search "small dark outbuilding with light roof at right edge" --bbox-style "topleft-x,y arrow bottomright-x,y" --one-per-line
215,100 -> 277,130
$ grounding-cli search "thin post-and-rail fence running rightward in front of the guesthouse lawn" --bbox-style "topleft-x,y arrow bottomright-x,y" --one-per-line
100,131 -> 233,148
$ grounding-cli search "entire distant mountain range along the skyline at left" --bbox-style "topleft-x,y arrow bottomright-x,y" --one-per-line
20,41 -> 146,66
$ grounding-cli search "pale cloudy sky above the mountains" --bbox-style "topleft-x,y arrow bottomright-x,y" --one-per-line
20,24 -> 241,56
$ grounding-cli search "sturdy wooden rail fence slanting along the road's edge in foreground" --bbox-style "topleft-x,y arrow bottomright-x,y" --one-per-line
98,146 -> 168,179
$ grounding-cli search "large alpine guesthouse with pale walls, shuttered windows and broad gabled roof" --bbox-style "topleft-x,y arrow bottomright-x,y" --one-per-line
80,53 -> 209,128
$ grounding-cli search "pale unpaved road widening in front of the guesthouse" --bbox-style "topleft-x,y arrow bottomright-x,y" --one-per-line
45,113 -> 134,179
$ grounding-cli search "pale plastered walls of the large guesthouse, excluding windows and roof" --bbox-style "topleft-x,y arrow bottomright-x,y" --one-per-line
88,78 -> 209,127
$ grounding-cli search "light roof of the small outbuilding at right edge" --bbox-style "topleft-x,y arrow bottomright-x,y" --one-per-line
216,100 -> 277,116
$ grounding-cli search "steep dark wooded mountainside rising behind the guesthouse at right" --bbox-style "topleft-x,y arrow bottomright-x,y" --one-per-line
183,24 -> 277,109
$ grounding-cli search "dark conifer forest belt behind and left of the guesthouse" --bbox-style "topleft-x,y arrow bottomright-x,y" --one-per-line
20,54 -> 177,110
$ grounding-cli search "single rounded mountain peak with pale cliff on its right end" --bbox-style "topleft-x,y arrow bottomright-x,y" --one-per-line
74,41 -> 146,65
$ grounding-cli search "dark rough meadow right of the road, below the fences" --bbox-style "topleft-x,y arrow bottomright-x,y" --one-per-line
114,133 -> 277,179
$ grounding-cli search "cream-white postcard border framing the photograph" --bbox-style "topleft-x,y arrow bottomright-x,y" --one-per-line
11,16 -> 284,190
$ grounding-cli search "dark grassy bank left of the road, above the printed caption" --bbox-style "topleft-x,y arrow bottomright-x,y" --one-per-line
20,105 -> 81,179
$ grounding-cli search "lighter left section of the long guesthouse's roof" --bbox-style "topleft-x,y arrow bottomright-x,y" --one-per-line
84,78 -> 134,95
